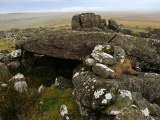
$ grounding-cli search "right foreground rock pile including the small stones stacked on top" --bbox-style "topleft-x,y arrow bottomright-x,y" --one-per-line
73,45 -> 160,120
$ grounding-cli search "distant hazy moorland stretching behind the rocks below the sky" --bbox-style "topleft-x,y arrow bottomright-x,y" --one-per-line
0,12 -> 160,30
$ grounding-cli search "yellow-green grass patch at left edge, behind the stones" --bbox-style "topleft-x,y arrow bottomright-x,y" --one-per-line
0,39 -> 15,52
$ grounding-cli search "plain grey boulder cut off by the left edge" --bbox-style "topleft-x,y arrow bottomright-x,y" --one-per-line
0,62 -> 12,82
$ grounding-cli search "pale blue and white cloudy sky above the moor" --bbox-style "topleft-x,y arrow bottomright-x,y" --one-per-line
0,0 -> 160,13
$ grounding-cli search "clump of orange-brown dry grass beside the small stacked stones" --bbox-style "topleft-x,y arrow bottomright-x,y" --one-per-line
111,59 -> 137,75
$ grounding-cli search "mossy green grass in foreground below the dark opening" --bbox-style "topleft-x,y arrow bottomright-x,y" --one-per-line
27,85 -> 82,120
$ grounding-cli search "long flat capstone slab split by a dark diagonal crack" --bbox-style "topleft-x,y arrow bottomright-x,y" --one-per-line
17,31 -> 160,69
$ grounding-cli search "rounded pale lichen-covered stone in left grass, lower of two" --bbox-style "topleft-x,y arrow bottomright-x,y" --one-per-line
14,81 -> 28,93
